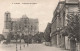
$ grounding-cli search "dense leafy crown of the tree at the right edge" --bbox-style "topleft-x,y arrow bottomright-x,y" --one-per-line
67,14 -> 79,40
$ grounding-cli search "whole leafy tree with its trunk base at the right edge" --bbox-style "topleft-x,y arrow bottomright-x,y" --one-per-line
67,14 -> 79,51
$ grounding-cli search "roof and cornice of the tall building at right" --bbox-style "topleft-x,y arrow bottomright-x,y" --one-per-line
52,0 -> 80,22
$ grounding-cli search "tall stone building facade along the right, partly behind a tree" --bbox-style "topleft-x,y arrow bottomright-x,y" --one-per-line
50,0 -> 80,49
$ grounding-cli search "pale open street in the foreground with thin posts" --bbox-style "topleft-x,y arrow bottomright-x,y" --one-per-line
0,44 -> 68,51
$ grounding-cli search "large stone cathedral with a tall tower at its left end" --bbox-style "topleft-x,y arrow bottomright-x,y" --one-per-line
3,12 -> 39,38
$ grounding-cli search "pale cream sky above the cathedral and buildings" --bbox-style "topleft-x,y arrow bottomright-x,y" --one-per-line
0,0 -> 59,33
